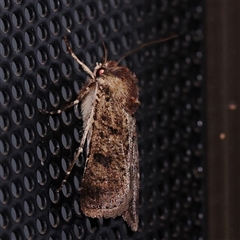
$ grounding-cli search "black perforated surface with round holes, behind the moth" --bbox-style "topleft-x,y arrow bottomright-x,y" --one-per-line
0,0 -> 206,240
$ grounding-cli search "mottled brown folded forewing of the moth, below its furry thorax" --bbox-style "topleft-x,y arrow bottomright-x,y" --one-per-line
81,84 -> 139,222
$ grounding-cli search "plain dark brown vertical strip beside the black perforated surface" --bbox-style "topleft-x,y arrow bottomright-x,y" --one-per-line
206,1 -> 240,240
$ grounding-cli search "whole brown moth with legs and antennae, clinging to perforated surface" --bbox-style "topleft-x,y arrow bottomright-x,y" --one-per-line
41,36 -> 175,231
